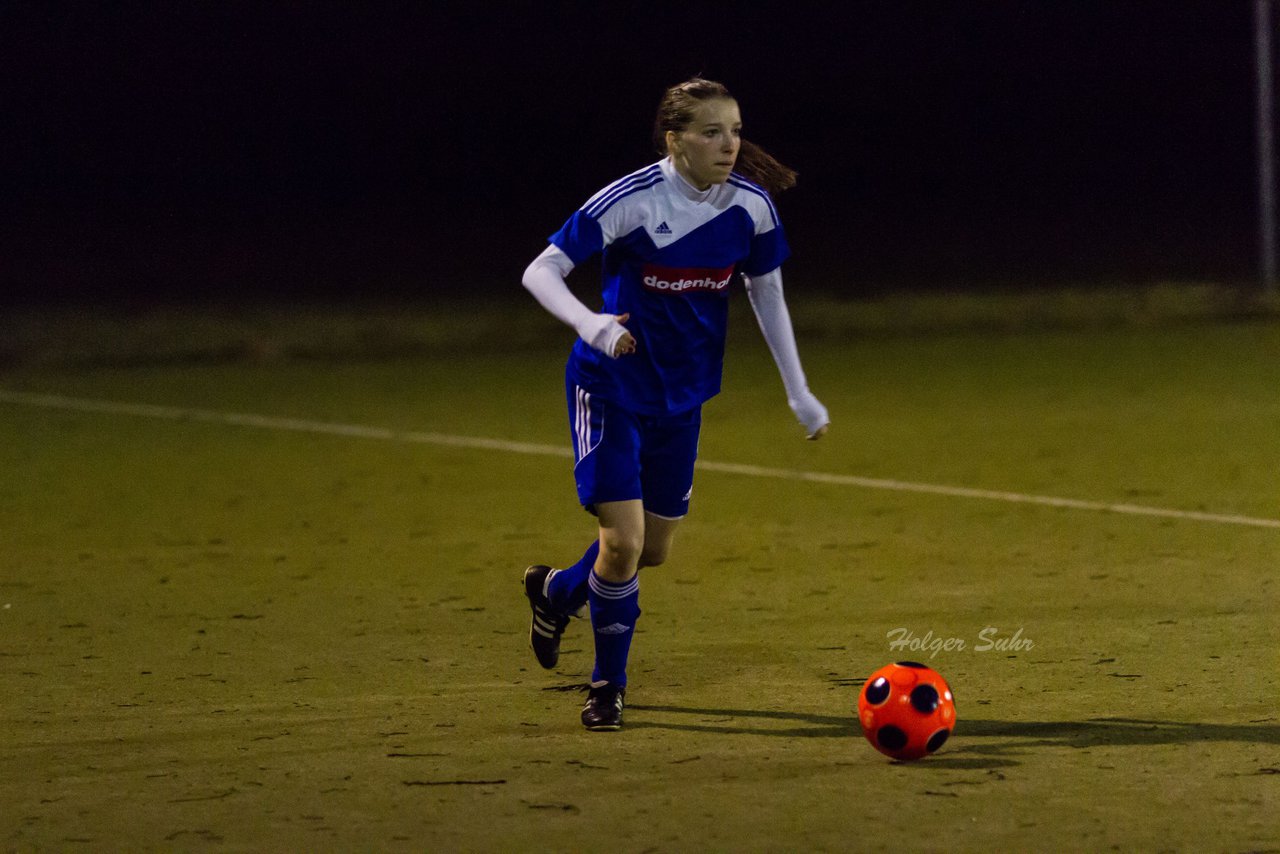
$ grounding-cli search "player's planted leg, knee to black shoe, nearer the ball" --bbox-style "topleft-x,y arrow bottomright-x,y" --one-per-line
582,498 -> 645,731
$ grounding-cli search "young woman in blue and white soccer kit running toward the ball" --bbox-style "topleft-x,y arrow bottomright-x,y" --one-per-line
524,78 -> 828,730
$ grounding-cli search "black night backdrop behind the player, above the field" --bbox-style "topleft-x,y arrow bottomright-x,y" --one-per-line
0,0 -> 1257,302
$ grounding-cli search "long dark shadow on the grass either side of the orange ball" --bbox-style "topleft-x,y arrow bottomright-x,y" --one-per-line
627,704 -> 1280,773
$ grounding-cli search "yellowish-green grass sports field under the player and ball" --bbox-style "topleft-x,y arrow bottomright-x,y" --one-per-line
0,291 -> 1280,851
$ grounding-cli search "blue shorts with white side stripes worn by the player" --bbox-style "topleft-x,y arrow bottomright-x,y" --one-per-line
564,379 -> 703,519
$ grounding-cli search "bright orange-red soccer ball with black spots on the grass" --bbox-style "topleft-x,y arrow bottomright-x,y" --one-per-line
858,661 -> 956,759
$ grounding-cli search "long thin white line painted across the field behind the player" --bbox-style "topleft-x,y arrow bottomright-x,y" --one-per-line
0,389 -> 1280,530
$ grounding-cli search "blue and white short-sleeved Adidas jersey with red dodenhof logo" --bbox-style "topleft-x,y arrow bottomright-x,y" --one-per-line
550,157 -> 790,415
